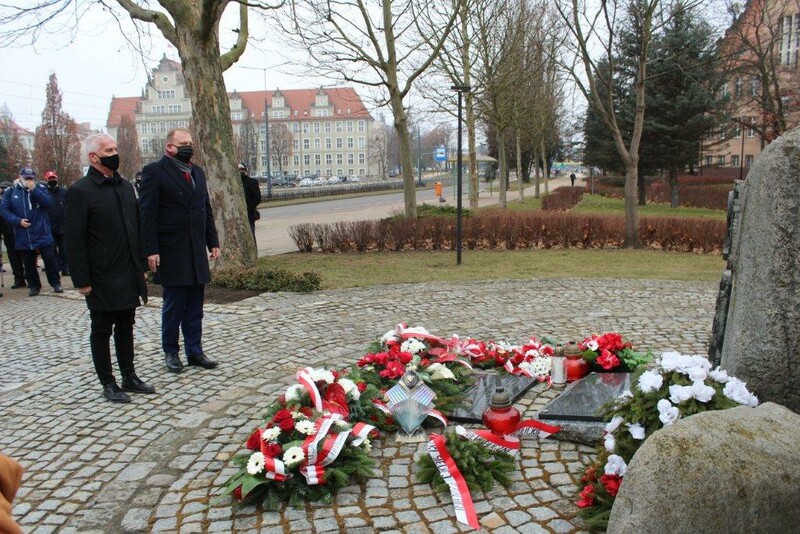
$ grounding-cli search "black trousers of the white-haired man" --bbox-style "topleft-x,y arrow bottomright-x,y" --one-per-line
89,308 -> 136,386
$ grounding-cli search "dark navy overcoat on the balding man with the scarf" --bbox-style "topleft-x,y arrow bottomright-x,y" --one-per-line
139,156 -> 219,286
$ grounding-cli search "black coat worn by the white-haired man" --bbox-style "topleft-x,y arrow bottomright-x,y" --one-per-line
64,167 -> 147,311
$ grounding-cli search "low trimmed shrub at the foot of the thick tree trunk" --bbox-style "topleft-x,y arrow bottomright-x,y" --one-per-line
216,265 -> 321,293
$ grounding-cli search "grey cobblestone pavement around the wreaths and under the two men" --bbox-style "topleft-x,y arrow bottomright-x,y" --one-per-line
0,280 -> 716,534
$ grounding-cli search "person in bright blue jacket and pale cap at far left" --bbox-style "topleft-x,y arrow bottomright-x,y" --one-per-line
0,167 -> 64,297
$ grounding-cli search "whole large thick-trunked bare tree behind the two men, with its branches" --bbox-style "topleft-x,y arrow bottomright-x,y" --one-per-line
0,0 -> 284,265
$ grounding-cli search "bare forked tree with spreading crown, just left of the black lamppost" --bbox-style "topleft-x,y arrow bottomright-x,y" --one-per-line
286,0 -> 464,218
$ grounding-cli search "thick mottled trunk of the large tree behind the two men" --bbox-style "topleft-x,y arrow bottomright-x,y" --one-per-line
176,31 -> 257,266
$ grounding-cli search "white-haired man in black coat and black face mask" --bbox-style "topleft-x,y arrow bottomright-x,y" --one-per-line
64,134 -> 155,402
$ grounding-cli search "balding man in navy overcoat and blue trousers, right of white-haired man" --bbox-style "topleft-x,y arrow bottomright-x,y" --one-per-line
139,129 -> 219,373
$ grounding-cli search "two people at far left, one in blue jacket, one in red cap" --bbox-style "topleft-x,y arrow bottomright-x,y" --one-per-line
0,171 -> 70,297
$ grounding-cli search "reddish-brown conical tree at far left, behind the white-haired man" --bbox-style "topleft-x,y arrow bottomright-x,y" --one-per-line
33,74 -> 81,184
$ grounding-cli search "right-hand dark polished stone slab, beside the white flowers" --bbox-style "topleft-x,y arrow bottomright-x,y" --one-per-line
539,373 -> 631,421
